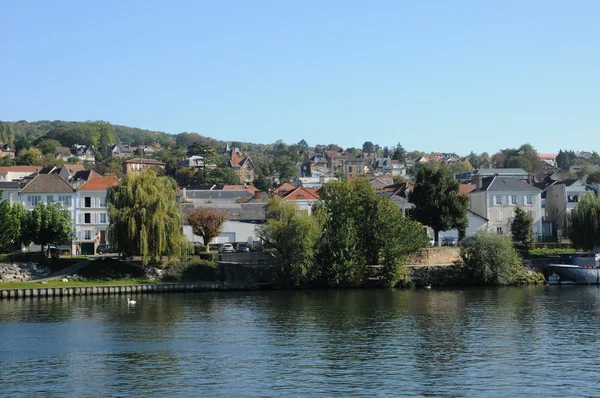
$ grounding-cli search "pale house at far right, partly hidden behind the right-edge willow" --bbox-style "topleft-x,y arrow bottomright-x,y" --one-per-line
545,179 -> 587,238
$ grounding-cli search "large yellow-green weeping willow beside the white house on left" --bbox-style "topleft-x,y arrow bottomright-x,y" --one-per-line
107,170 -> 188,264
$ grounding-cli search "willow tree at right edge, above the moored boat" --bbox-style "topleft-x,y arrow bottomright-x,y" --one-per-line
568,193 -> 600,250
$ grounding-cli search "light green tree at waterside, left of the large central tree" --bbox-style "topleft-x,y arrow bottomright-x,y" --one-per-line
258,196 -> 320,287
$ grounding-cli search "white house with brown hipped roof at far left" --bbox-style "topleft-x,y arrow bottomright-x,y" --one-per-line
19,173 -> 77,252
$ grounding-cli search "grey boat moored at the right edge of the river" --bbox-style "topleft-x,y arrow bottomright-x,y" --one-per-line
544,253 -> 600,285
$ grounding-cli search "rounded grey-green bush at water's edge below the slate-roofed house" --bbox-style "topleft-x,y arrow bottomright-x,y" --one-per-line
460,233 -> 523,285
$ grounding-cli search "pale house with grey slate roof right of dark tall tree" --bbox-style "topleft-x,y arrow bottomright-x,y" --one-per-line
469,175 -> 543,235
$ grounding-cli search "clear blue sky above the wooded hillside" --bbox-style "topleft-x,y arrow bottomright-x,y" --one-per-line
0,0 -> 600,154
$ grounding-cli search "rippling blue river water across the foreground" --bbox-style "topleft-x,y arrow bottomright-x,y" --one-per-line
0,286 -> 600,397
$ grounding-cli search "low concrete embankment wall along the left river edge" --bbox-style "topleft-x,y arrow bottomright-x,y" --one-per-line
0,282 -> 226,299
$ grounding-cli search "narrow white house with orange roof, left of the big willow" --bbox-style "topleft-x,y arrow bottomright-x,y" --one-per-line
74,175 -> 119,254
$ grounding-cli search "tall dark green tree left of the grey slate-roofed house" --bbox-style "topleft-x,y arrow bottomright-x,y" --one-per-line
408,165 -> 469,244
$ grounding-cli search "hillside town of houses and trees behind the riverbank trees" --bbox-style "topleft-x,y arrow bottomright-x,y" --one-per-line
0,122 -> 600,254
